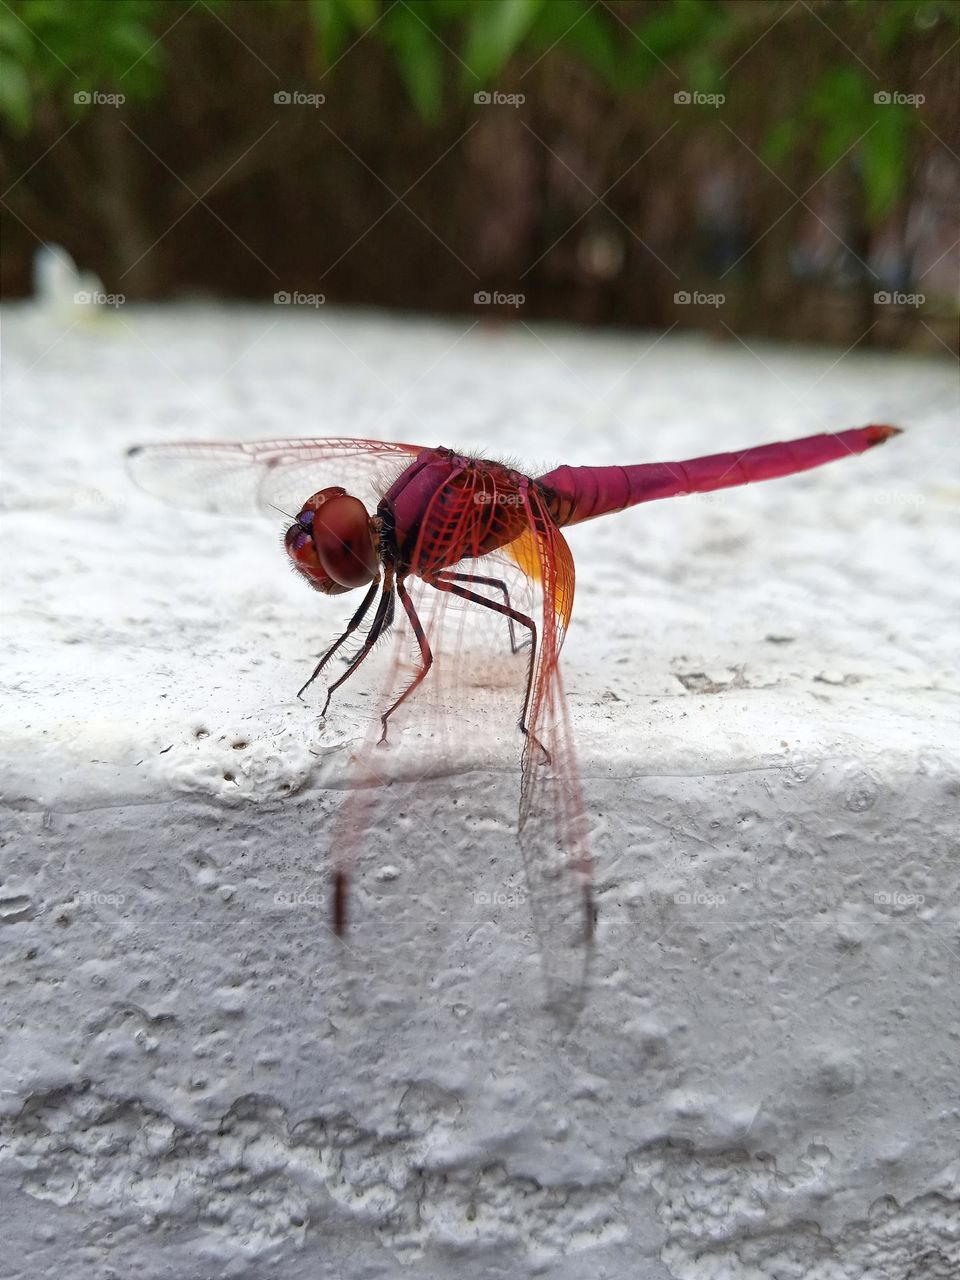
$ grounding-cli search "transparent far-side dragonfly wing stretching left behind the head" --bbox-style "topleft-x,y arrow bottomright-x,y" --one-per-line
127,439 -> 421,516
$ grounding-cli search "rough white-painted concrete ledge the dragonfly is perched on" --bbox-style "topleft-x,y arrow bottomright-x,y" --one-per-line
0,305 -> 960,1280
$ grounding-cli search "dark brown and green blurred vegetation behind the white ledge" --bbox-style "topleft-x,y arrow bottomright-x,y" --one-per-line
0,0 -> 960,352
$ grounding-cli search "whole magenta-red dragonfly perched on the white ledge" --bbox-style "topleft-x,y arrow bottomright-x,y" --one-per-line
129,426 -> 899,992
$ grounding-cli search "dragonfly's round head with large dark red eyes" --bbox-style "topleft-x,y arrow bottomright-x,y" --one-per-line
284,486 -> 380,595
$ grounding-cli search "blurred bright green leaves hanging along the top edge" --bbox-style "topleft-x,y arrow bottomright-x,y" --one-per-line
0,0 -> 960,224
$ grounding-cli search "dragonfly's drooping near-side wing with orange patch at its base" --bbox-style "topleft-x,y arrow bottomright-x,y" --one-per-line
509,490 -> 593,1019
